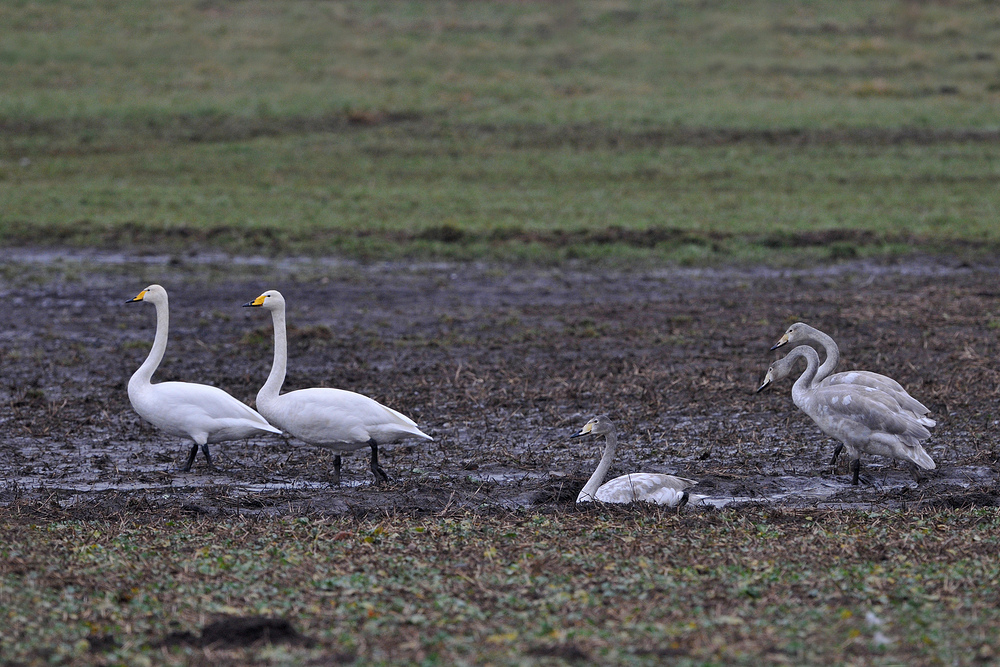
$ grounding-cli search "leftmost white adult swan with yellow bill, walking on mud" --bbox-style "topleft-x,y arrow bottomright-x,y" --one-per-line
125,285 -> 281,472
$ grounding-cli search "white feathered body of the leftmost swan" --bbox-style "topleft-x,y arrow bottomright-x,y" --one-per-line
128,380 -> 281,443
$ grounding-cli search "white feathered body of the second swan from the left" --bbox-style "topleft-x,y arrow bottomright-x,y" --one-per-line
266,387 -> 433,449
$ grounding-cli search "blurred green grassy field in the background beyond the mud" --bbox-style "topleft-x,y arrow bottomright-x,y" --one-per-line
0,1 -> 1000,263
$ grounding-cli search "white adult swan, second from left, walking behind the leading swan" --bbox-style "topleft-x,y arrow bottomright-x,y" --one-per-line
243,290 -> 434,484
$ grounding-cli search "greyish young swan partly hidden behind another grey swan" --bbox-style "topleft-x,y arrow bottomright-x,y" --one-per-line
771,322 -> 937,465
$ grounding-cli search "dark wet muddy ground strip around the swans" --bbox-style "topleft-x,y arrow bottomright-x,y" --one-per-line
0,250 -> 1000,518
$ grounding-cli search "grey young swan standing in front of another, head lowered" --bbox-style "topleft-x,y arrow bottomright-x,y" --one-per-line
757,345 -> 937,484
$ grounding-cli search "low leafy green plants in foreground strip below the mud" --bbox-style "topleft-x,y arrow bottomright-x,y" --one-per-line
0,508 -> 1000,665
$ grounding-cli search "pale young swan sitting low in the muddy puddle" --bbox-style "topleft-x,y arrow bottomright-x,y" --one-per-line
570,415 -> 698,506
